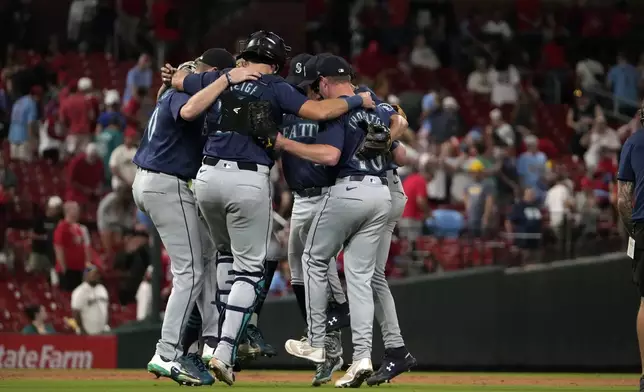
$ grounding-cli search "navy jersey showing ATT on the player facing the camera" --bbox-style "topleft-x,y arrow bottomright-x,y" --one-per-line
281,114 -> 335,191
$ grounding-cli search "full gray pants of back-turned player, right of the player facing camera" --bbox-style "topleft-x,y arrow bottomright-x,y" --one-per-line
302,176 -> 391,361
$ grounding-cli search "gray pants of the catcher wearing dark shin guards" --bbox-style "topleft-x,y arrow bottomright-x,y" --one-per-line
194,160 -> 273,365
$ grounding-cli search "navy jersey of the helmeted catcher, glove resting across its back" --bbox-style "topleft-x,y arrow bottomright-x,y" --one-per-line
183,70 -> 307,166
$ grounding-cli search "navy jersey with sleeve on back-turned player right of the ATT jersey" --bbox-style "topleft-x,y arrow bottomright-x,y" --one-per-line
318,99 -> 396,178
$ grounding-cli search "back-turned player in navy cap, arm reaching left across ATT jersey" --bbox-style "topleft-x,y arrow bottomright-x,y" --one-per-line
276,56 -> 396,387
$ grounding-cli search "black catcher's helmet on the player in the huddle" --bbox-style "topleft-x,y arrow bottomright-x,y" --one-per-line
237,30 -> 291,72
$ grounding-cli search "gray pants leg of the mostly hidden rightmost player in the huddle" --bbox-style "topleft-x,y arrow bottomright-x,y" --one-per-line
371,170 -> 407,348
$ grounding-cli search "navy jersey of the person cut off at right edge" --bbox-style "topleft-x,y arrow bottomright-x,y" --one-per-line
617,129 -> 644,222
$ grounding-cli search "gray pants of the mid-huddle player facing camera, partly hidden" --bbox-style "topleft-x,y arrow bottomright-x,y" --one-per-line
288,188 -> 347,304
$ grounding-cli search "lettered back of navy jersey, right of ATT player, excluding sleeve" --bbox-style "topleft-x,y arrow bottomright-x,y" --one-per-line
335,104 -> 395,178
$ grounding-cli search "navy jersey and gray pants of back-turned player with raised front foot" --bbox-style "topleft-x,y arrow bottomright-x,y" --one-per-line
302,102 -> 395,362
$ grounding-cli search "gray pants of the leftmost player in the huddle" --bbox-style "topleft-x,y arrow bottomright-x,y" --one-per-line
132,169 -> 208,360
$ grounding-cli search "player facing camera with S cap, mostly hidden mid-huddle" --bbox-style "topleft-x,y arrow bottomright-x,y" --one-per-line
281,53 -> 349,386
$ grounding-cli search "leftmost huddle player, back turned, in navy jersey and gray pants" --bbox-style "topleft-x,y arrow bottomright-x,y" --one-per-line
132,49 -> 254,385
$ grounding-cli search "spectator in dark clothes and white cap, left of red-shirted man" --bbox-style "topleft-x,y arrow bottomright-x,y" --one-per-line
25,196 -> 63,272
